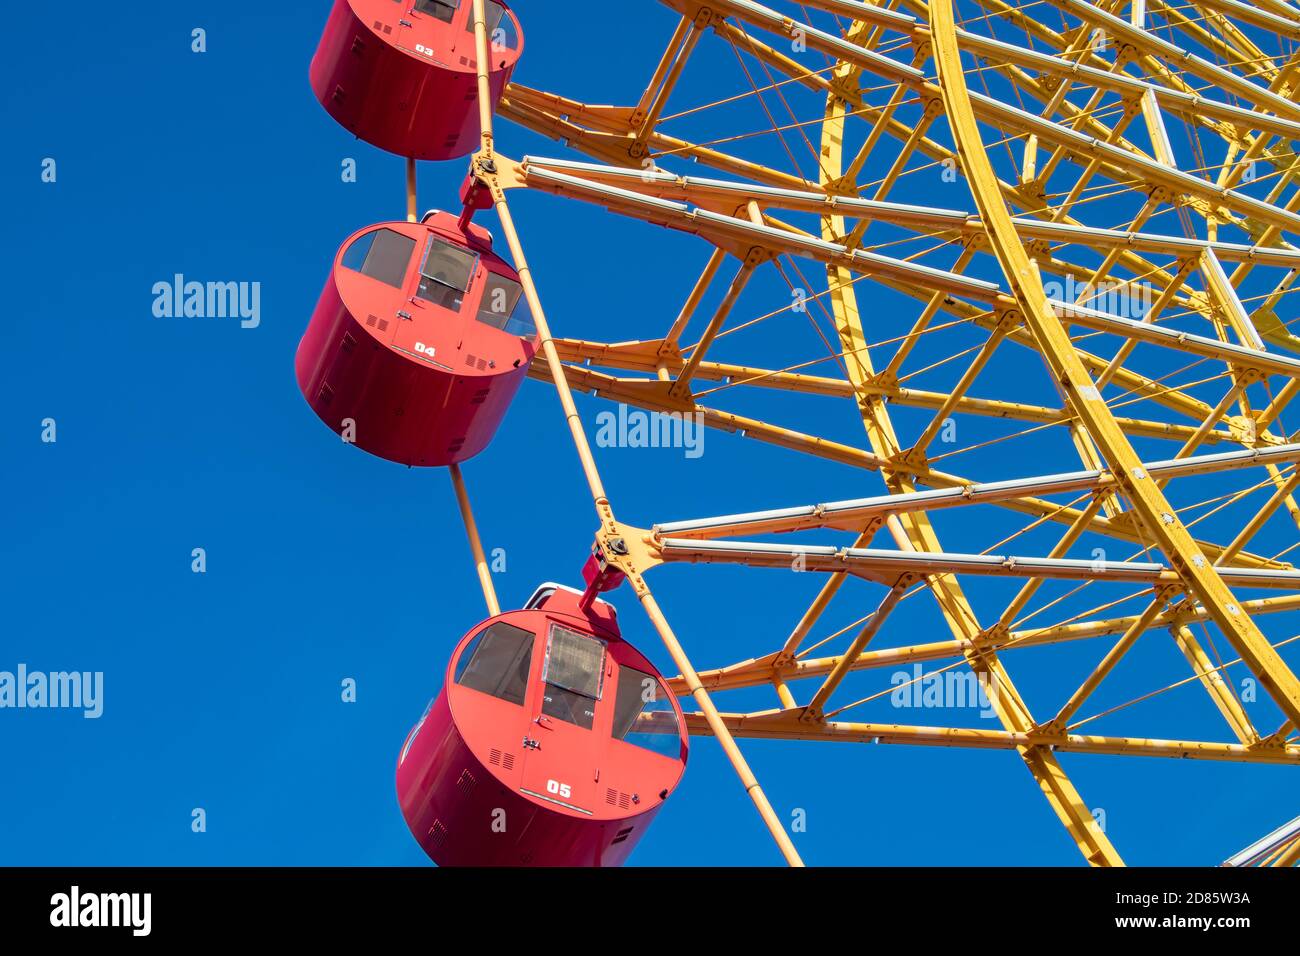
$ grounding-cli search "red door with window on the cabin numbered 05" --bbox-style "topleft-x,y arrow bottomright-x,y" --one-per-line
521,622 -> 614,813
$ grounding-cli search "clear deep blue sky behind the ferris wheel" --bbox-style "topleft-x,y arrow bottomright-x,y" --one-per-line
0,0 -> 1297,865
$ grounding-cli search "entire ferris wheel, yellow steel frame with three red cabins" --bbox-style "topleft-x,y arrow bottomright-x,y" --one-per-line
298,0 -> 1300,866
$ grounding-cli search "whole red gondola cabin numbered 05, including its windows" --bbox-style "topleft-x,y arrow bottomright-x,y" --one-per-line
397,584 -> 686,866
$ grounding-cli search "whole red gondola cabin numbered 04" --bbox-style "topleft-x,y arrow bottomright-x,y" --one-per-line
295,212 -> 537,467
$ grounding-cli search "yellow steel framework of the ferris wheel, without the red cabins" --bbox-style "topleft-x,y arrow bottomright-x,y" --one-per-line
452,0 -> 1300,865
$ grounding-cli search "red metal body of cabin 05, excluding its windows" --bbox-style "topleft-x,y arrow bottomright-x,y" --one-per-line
397,592 -> 686,866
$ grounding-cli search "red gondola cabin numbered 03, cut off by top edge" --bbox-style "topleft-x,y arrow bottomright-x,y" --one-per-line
311,0 -> 524,160
